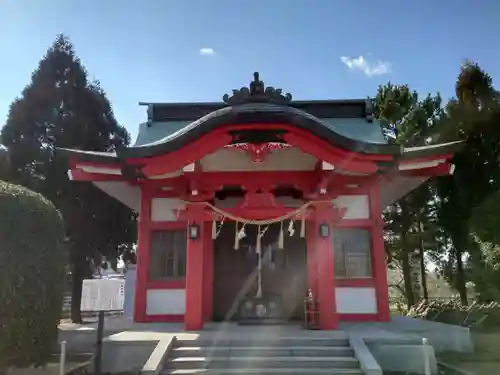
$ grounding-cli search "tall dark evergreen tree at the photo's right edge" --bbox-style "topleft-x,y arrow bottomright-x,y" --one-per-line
436,62 -> 500,304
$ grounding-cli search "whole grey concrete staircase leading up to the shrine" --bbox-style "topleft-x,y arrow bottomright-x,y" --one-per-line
162,337 -> 363,375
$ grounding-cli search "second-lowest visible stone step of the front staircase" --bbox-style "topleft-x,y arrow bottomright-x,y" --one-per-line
166,356 -> 359,371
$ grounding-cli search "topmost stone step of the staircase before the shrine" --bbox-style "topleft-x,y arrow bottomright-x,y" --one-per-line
175,337 -> 349,347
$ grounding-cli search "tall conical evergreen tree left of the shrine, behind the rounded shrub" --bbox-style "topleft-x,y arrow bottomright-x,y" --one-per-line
1,35 -> 135,322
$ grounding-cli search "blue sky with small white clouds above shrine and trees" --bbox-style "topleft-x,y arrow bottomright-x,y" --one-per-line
0,0 -> 500,142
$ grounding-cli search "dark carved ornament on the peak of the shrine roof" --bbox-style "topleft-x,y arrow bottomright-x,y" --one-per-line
222,72 -> 292,105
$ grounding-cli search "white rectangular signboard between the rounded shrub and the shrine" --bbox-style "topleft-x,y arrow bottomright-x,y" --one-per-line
80,279 -> 125,311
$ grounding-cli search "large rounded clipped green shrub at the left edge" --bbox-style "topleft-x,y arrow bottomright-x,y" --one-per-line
0,181 -> 65,373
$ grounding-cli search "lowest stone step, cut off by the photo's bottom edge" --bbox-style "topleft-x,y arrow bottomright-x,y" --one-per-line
161,368 -> 363,375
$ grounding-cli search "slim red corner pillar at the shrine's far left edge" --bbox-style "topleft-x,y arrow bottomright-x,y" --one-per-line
134,189 -> 151,322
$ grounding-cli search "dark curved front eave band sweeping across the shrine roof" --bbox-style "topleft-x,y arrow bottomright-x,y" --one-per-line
59,104 -> 460,164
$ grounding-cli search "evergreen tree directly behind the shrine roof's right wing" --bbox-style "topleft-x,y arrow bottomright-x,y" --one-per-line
375,83 -> 442,307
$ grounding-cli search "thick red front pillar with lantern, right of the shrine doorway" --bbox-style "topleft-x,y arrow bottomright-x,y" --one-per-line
311,204 -> 338,330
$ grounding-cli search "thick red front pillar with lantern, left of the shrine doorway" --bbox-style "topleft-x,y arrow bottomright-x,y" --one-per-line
184,206 -> 206,331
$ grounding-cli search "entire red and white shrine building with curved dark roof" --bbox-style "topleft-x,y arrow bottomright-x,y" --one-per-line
59,73 -> 457,330
